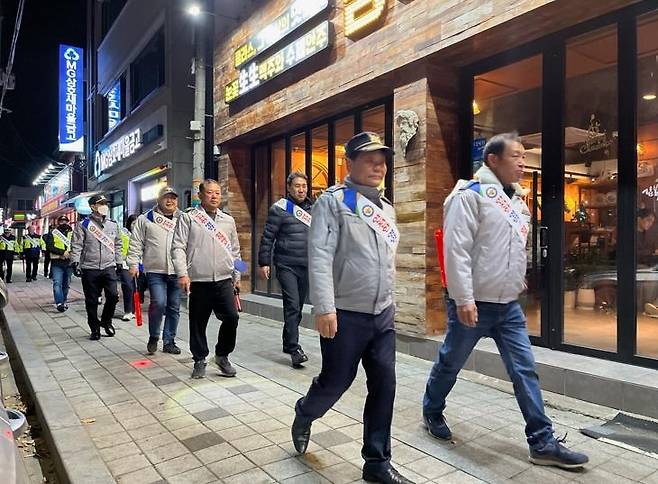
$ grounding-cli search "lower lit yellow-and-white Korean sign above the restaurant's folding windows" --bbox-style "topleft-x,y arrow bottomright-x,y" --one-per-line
224,21 -> 329,103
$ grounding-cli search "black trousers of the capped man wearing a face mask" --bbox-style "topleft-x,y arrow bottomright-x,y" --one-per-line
82,266 -> 119,331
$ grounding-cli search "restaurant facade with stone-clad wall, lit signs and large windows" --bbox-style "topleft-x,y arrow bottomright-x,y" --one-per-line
215,0 -> 658,367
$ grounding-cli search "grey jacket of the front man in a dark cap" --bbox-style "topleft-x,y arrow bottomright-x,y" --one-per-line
308,178 -> 395,314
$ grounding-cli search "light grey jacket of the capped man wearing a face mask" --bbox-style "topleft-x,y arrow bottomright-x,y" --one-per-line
71,214 -> 123,270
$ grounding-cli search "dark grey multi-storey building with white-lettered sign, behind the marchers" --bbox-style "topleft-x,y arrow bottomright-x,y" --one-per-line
86,0 -> 194,227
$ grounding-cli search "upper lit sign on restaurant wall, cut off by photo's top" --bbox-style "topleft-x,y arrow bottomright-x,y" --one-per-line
234,0 -> 329,67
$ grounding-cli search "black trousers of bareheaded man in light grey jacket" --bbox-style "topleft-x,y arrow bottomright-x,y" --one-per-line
189,279 -> 239,361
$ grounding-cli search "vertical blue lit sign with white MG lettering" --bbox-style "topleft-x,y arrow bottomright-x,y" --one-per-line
59,44 -> 85,153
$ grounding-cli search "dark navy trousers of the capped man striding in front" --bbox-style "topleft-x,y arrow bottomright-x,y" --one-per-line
295,305 -> 395,471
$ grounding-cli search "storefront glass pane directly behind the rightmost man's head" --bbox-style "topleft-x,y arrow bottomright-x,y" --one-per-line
471,55 -> 543,336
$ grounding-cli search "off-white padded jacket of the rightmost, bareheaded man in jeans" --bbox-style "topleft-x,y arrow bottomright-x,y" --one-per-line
443,165 -> 530,306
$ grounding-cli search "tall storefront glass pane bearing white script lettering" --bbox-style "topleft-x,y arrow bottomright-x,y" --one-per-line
563,26 -> 618,352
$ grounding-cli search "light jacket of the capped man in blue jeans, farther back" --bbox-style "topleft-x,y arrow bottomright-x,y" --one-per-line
127,205 -> 183,274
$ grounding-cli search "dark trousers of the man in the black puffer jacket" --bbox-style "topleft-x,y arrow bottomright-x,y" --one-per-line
276,264 -> 308,353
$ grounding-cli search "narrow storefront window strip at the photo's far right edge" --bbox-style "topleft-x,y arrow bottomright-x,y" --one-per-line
636,13 -> 658,358
